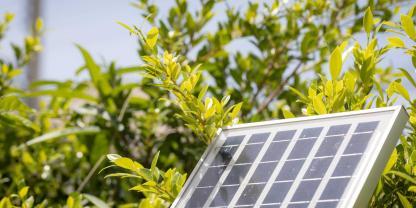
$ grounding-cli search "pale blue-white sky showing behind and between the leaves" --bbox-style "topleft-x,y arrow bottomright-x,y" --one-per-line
0,0 -> 412,93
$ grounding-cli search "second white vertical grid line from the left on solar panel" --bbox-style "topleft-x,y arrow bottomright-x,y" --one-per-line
224,132 -> 277,207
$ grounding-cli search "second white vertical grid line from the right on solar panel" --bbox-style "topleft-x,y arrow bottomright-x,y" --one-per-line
282,126 -> 329,207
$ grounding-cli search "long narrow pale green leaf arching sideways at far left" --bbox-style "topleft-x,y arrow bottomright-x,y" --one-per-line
20,126 -> 101,148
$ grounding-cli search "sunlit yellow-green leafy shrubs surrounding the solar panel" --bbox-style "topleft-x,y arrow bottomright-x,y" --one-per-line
0,0 -> 416,208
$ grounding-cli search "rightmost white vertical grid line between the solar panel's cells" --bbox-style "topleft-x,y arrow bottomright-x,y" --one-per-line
309,123 -> 357,208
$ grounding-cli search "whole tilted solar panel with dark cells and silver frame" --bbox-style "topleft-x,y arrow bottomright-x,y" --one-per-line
172,106 -> 408,208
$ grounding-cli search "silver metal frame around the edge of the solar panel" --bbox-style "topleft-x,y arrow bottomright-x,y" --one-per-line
171,106 -> 409,208
